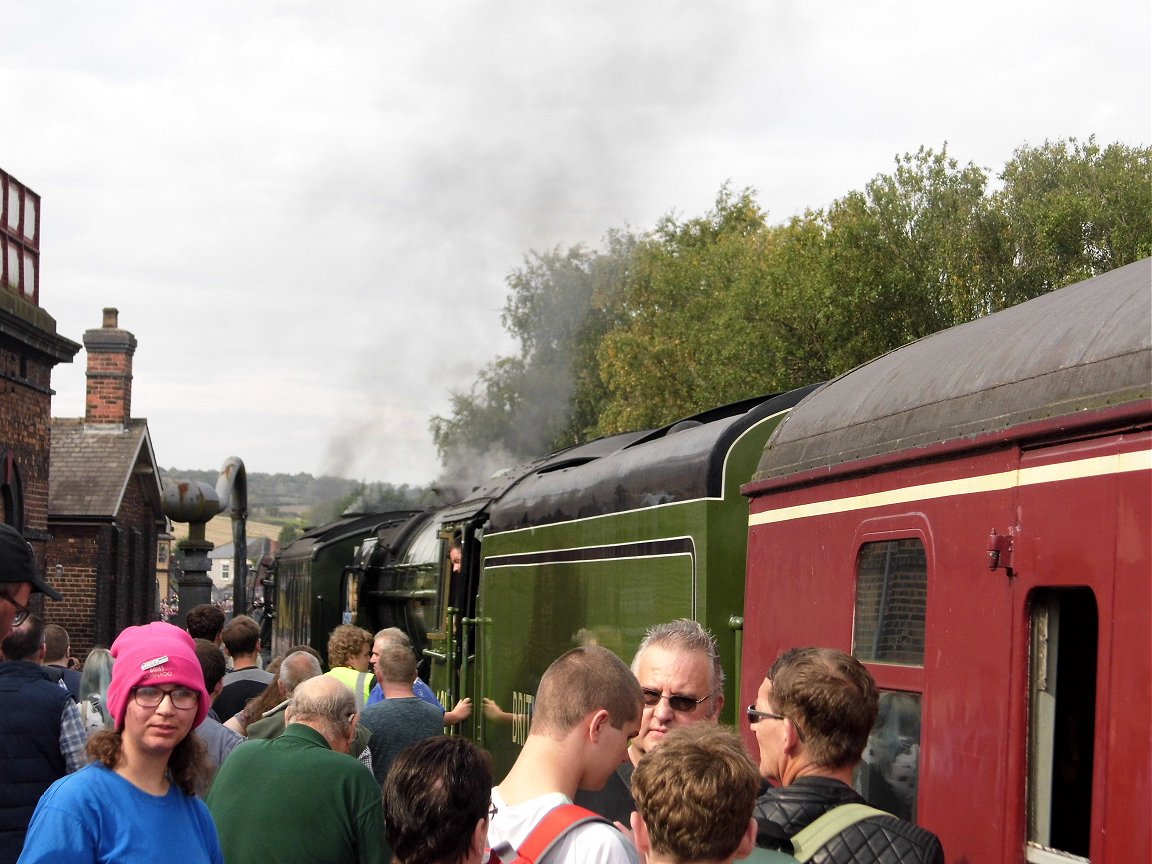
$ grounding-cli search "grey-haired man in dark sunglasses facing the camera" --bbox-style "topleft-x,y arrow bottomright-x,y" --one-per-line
576,619 -> 723,826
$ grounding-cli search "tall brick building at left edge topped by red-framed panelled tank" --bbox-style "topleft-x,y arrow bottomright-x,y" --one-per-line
0,170 -> 79,621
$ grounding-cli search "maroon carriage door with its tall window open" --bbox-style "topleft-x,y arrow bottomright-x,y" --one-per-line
1000,438 -> 1126,864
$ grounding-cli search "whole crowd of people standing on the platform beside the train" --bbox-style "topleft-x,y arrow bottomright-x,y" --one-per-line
0,525 -> 943,864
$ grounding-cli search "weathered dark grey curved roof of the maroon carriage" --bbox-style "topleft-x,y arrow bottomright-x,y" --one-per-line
749,259 -> 1152,493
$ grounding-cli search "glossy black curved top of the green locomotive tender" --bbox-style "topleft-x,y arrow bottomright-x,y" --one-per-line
491,387 -> 812,531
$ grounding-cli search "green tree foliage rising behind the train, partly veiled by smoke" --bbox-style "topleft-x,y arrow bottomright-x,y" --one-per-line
432,138 -> 1152,462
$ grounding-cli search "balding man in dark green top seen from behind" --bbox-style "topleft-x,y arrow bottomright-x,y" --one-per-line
206,675 -> 386,864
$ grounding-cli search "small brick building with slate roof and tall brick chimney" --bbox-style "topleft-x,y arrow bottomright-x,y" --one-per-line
47,309 -> 167,657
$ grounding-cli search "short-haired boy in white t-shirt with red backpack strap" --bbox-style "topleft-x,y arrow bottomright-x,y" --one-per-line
488,645 -> 643,864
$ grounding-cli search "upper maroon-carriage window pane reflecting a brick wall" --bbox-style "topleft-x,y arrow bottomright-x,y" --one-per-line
852,538 -> 929,666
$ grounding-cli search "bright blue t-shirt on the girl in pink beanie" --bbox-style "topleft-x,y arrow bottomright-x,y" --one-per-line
20,763 -> 223,864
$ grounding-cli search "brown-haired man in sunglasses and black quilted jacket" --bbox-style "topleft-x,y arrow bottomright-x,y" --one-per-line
748,647 -> 943,864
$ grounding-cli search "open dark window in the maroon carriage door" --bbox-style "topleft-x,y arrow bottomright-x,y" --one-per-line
1025,588 -> 1097,862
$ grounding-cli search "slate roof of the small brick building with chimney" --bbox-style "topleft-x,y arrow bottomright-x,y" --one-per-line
48,417 -> 160,518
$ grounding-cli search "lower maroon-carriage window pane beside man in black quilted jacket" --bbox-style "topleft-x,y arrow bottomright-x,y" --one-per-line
854,691 -> 920,821
